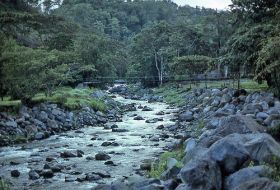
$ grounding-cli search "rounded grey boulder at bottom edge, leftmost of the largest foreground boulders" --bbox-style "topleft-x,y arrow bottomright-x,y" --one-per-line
180,157 -> 222,190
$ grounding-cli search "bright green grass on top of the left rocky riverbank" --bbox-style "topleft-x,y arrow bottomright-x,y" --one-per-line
0,87 -> 107,112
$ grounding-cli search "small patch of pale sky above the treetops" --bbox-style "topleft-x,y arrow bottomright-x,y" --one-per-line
173,0 -> 231,9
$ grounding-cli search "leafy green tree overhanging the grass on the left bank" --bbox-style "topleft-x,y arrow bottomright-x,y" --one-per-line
0,39 -> 74,103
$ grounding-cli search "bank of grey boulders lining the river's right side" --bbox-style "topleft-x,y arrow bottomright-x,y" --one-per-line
95,85 -> 280,190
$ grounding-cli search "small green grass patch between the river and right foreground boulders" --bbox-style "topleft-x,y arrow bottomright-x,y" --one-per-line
148,147 -> 184,178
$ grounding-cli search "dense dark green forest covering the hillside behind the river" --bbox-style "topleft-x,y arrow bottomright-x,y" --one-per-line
0,0 -> 280,102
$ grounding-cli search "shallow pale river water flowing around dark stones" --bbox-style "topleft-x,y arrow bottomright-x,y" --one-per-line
0,96 -> 176,190
